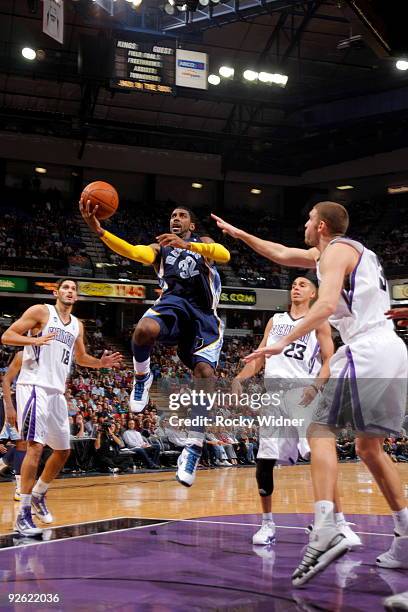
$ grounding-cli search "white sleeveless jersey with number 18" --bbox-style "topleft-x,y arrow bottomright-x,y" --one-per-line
17,304 -> 79,393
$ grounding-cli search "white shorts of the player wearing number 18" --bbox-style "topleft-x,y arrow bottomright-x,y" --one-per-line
16,384 -> 70,450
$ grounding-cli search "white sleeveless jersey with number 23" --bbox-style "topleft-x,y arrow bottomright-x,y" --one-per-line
265,312 -> 321,379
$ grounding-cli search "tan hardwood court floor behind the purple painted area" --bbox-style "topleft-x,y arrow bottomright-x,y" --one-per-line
0,463 -> 408,534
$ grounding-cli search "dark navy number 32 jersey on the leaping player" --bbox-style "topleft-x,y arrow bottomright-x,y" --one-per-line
156,234 -> 221,310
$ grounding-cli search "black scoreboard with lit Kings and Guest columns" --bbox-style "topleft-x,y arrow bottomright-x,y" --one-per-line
110,40 -> 175,94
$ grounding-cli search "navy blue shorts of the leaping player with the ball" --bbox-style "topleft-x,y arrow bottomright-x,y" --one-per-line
142,295 -> 224,370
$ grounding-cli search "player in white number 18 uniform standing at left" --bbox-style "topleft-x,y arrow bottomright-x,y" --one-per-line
1,279 -> 121,537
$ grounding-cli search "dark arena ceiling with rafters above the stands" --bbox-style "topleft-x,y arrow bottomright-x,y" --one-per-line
0,0 -> 408,175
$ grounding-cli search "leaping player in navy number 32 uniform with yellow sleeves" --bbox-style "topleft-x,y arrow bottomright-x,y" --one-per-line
80,201 -> 230,486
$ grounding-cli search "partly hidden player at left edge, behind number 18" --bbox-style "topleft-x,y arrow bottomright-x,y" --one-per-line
2,351 -> 27,501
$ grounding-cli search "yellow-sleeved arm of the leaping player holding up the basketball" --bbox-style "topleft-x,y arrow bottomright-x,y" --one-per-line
79,198 -> 159,265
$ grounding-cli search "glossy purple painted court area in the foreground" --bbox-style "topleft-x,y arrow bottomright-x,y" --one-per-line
0,514 -> 408,612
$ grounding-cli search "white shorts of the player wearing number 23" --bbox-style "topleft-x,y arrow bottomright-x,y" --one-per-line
257,387 -> 316,465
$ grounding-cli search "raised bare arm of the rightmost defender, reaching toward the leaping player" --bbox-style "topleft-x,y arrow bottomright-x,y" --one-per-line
211,214 -> 319,268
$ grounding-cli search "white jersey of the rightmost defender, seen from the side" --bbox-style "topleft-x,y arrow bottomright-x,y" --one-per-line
317,237 -> 394,344
